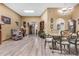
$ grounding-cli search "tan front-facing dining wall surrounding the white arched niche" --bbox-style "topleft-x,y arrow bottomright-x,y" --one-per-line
48,8 -> 71,34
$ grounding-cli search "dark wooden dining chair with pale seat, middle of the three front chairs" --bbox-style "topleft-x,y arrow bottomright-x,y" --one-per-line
57,30 -> 70,54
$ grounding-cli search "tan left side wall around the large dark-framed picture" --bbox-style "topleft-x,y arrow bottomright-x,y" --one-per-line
0,3 -> 21,41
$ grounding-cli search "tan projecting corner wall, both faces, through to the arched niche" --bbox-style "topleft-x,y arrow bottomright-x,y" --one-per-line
41,8 -> 71,34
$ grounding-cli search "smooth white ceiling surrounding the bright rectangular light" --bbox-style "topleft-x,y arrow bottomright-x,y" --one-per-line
4,3 -> 76,16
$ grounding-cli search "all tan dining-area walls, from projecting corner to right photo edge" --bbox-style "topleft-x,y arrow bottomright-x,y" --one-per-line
41,4 -> 79,34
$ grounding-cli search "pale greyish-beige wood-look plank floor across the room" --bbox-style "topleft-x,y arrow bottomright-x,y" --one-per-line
0,35 -> 78,56
